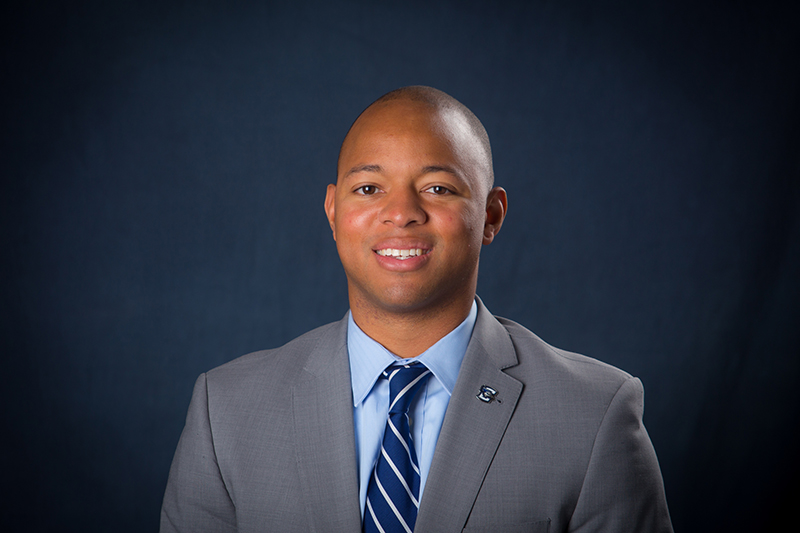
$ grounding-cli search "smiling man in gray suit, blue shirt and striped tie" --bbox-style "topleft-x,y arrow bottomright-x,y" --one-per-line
161,87 -> 672,533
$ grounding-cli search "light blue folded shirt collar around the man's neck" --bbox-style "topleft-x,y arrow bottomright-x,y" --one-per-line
347,301 -> 478,405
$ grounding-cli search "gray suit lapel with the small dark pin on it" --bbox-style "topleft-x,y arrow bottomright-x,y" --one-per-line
415,300 -> 522,533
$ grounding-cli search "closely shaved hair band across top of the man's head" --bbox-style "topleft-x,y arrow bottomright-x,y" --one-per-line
339,85 -> 494,193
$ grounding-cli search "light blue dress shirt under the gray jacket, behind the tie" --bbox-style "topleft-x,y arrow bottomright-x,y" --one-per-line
347,302 -> 478,517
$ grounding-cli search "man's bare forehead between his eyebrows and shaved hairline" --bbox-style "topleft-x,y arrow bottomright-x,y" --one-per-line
338,100 -> 490,187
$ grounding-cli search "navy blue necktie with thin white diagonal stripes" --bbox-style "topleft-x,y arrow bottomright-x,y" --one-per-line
364,363 -> 431,533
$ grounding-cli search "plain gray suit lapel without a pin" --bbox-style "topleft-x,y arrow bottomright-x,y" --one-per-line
292,318 -> 361,531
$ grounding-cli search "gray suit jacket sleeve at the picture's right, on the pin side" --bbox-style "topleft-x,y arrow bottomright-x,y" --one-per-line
569,378 -> 672,533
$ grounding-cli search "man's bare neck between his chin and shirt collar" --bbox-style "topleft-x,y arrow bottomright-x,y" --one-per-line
350,295 -> 475,359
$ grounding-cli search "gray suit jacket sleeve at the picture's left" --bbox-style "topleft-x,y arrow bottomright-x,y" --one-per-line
160,374 -> 236,533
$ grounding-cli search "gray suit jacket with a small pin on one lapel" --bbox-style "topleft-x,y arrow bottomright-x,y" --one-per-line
161,300 -> 672,533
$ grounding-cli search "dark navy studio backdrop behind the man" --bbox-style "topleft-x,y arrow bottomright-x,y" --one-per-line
0,1 -> 800,532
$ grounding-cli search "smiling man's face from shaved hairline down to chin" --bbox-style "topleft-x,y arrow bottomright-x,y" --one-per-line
325,100 -> 502,313
